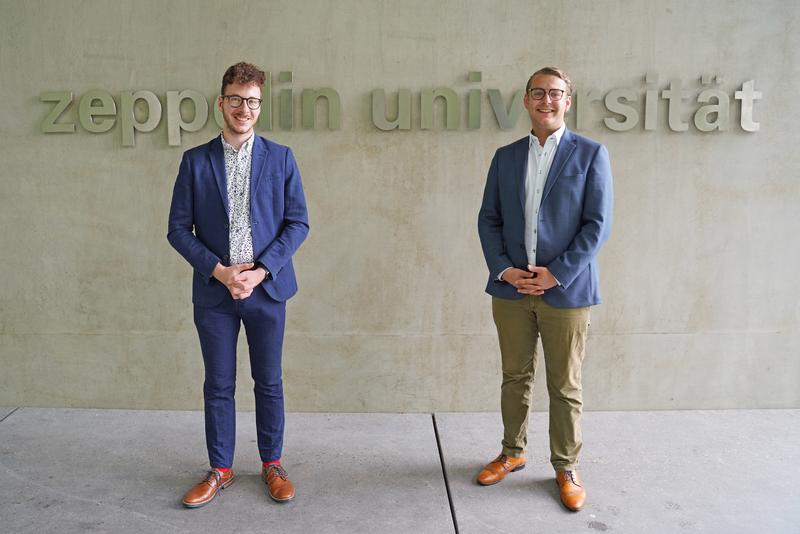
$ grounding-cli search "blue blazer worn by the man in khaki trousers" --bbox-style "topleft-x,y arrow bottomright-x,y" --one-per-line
478,129 -> 613,308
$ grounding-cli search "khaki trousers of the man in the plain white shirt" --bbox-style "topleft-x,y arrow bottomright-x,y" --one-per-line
492,295 -> 589,471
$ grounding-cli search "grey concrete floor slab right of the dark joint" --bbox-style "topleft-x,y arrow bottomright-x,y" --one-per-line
436,410 -> 800,534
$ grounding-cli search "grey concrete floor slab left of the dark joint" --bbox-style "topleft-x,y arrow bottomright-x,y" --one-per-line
0,408 -> 453,534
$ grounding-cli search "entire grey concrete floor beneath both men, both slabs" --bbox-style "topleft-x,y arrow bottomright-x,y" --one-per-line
0,408 -> 800,534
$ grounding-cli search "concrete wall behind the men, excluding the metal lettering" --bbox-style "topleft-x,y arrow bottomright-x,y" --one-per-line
0,0 -> 800,411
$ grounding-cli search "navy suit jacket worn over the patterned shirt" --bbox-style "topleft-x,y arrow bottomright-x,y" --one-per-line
167,135 -> 308,307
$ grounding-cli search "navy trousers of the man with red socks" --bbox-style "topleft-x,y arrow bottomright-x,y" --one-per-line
194,284 -> 286,468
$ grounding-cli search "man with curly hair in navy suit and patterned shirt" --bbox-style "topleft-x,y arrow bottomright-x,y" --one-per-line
167,62 -> 308,508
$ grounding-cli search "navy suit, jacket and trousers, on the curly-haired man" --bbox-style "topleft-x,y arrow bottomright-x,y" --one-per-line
167,135 -> 308,467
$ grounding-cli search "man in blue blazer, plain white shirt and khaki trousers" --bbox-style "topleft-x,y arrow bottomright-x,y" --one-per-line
477,67 -> 612,511
